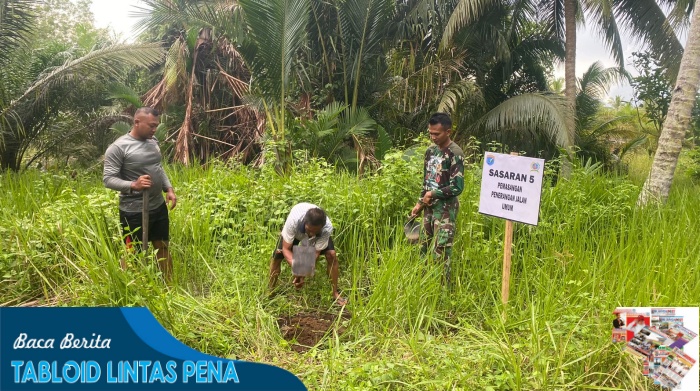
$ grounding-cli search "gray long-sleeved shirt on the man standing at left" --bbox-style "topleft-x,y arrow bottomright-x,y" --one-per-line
102,133 -> 172,212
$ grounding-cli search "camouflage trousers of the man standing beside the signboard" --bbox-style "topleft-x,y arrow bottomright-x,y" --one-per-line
421,198 -> 459,282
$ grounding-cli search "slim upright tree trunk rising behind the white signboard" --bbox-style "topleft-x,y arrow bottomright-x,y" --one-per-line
561,0 -> 577,178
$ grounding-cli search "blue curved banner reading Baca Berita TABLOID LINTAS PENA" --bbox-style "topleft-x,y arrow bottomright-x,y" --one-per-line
0,308 -> 306,391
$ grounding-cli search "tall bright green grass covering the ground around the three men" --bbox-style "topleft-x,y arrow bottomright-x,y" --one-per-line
0,156 -> 700,390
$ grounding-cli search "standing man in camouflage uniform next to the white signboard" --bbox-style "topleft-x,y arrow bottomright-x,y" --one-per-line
411,113 -> 464,282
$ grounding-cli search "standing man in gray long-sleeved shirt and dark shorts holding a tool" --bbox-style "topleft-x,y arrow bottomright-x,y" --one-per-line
102,107 -> 177,280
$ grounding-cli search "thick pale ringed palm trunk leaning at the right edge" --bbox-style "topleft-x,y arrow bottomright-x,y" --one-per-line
637,1 -> 700,206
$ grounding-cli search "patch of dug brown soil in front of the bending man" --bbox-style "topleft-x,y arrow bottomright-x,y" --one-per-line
277,312 -> 350,353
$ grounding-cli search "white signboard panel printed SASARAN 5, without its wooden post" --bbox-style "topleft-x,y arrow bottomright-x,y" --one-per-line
479,152 -> 544,225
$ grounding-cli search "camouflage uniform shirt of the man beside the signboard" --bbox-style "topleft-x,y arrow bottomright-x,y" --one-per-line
420,141 -> 464,200
